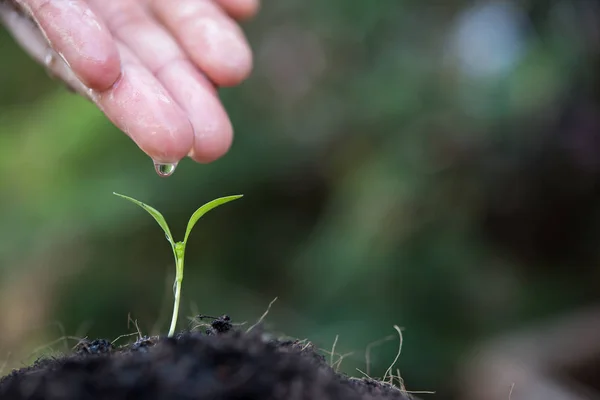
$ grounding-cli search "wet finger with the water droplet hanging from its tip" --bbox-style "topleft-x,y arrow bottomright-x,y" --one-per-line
94,45 -> 194,163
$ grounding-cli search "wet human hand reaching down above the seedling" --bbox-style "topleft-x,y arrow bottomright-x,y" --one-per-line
0,0 -> 259,163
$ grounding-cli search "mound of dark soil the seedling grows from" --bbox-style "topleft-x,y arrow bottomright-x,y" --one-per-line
0,316 -> 413,400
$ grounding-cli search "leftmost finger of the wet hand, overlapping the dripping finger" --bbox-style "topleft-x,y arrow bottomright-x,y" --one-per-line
19,0 -> 121,90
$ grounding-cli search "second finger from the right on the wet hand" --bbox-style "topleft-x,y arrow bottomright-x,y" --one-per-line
150,0 -> 252,86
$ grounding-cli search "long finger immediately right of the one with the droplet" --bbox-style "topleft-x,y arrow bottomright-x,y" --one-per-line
92,0 -> 232,162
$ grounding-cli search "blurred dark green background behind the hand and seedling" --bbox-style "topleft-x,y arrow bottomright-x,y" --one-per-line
0,0 -> 600,399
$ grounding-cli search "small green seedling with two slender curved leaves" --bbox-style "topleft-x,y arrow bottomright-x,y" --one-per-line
113,192 -> 243,336
